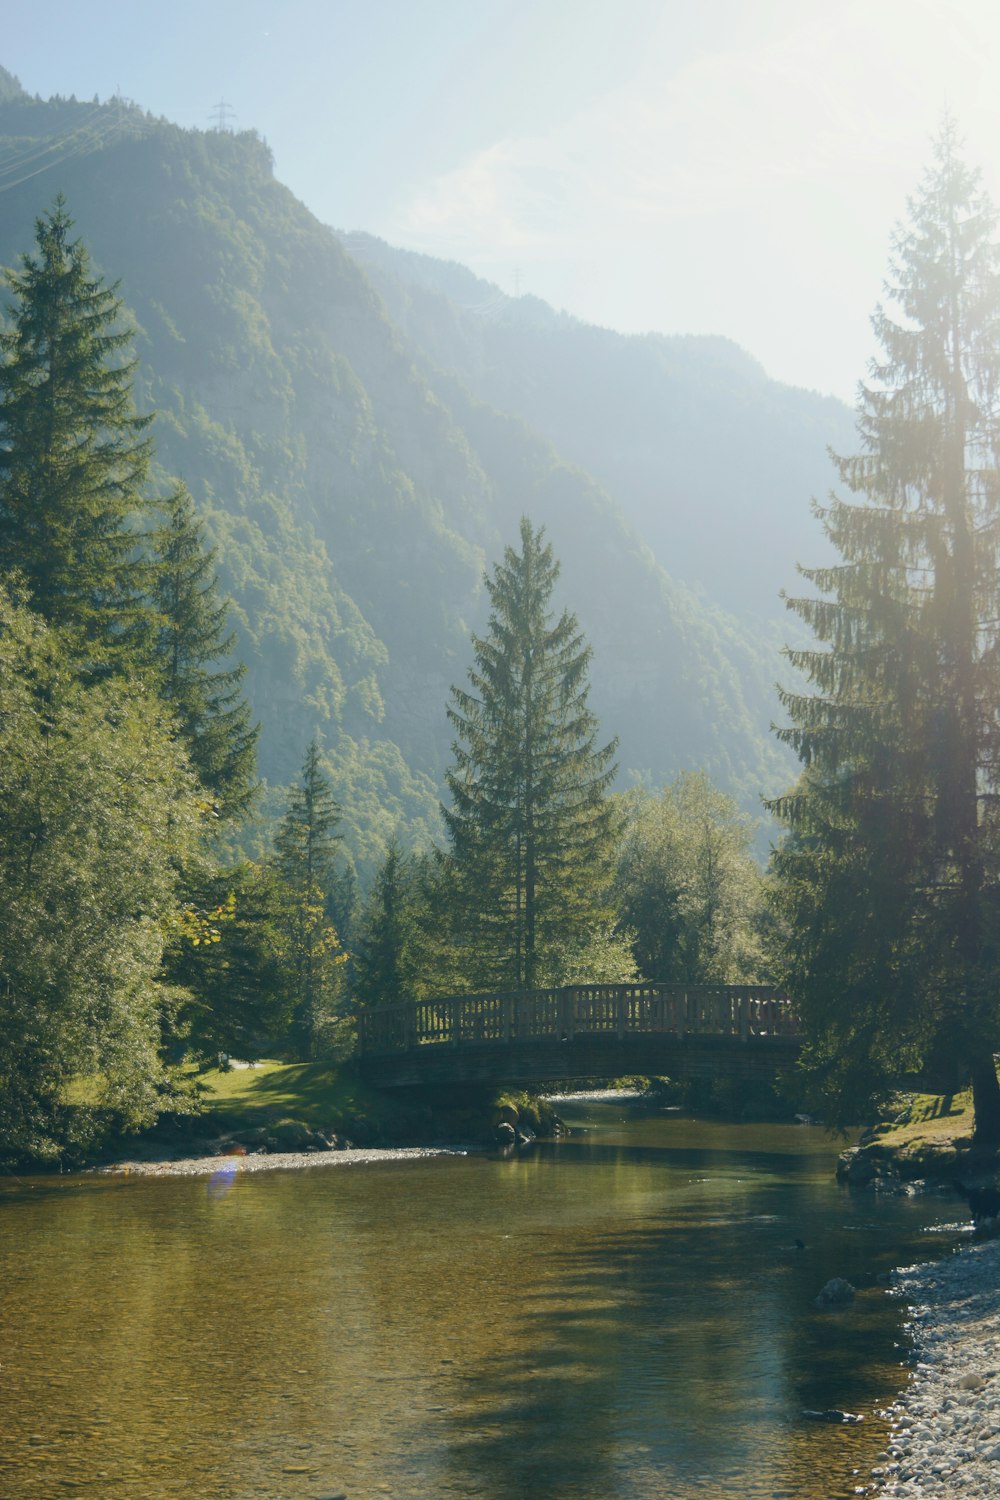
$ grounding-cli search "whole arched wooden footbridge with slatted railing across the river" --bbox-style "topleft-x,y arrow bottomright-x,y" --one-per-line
358,984 -> 799,1088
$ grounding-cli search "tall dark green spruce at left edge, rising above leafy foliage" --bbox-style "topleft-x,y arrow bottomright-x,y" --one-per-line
0,198 -> 151,666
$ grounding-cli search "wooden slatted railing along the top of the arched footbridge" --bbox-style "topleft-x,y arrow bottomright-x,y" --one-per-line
358,984 -> 799,1055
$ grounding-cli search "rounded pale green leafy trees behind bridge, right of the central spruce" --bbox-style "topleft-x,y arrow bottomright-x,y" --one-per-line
615,773 -> 762,984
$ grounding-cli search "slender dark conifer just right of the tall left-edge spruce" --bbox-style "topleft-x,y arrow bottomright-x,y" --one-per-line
153,486 -> 258,816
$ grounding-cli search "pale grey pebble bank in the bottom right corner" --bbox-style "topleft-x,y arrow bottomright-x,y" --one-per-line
876,1239 -> 1000,1500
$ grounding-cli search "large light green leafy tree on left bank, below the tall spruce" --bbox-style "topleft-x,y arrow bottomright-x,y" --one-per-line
0,596 -> 199,1158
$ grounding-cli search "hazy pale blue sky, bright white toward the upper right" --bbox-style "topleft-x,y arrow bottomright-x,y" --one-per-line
0,0 -> 1000,402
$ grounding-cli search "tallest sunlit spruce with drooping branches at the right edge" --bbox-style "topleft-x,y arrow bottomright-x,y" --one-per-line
775,125 -> 1000,1142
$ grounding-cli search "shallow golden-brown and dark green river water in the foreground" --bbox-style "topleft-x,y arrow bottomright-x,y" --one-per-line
0,1101 -> 958,1500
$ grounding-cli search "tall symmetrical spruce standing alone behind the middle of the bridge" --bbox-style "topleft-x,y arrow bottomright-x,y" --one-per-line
444,518 -> 616,989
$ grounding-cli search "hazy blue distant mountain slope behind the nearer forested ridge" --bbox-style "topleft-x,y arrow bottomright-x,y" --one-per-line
342,234 -> 861,617
